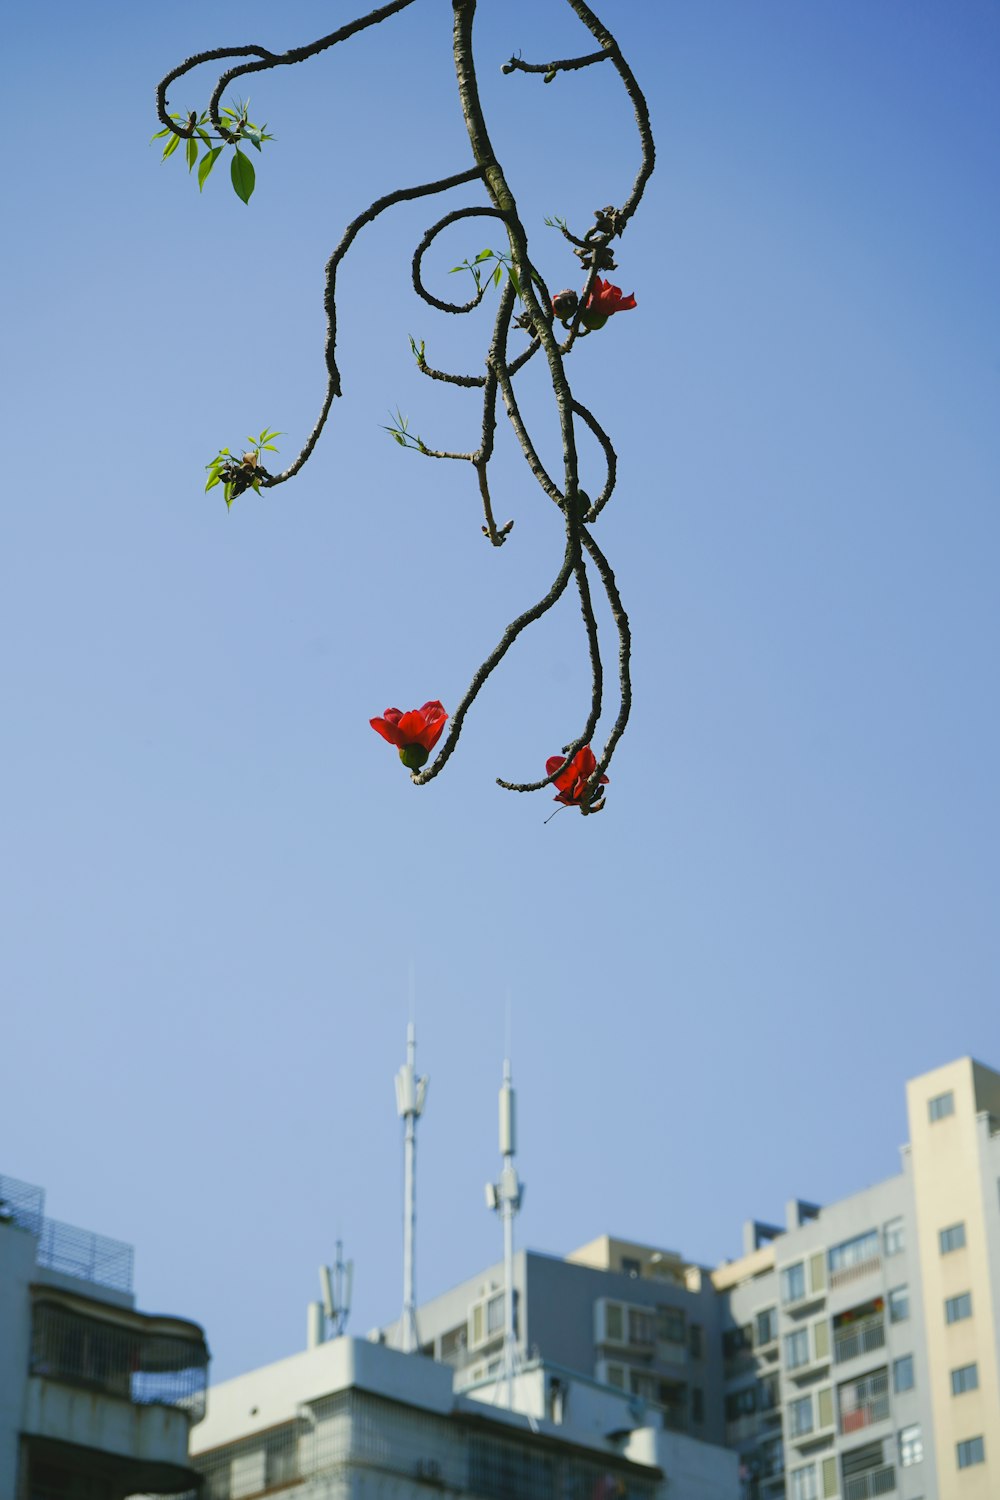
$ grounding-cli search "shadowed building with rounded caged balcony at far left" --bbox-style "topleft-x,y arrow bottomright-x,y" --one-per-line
0,1176 -> 208,1500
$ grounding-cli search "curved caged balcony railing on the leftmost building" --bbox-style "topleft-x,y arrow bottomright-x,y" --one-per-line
30,1301 -> 208,1422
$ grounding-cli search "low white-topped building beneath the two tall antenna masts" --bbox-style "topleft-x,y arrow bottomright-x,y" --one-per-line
190,1338 -> 739,1500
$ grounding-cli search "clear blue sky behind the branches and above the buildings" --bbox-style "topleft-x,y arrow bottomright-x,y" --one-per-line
0,0 -> 1000,1377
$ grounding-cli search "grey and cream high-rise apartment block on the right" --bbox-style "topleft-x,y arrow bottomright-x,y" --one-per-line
379,1058 -> 1000,1500
